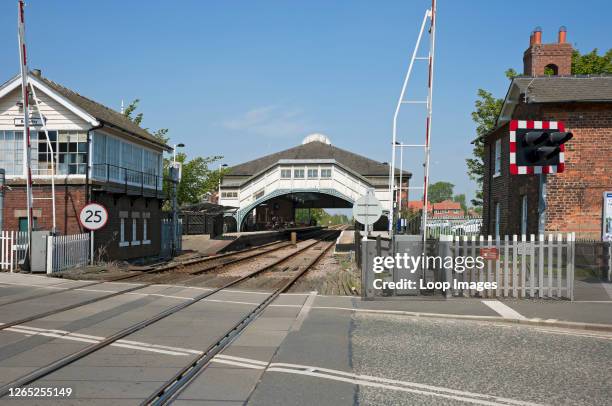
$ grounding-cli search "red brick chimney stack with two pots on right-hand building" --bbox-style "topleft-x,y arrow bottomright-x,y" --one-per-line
523,26 -> 573,76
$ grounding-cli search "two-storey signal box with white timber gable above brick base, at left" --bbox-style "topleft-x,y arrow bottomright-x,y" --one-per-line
0,70 -> 171,259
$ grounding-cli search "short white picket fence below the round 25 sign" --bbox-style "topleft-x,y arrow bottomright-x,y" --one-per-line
47,233 -> 90,274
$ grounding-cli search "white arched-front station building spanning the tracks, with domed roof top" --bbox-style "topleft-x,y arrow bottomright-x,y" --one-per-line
219,134 -> 410,231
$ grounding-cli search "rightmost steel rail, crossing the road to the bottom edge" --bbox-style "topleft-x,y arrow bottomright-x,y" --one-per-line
141,233 -> 335,406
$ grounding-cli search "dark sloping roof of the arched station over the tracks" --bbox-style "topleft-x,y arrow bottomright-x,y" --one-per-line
226,141 -> 410,176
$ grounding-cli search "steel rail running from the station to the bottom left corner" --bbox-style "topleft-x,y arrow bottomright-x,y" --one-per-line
0,234 -> 338,398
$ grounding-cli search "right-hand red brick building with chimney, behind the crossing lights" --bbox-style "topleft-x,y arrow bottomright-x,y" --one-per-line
483,27 -> 612,239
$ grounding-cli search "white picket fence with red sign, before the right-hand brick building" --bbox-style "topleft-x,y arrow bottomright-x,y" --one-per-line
440,233 -> 575,300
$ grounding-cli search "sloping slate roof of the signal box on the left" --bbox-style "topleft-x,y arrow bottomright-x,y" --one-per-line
0,72 -> 172,151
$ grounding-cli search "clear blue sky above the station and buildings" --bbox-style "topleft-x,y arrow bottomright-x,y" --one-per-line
0,0 -> 612,203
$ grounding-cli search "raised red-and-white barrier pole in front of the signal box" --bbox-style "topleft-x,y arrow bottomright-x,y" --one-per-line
17,0 -> 33,265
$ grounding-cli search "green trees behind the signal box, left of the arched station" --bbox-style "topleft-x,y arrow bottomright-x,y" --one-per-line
123,99 -> 228,206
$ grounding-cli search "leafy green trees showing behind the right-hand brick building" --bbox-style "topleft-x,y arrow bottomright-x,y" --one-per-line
466,49 -> 612,207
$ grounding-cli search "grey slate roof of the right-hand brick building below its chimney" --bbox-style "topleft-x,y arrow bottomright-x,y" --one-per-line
512,75 -> 612,103
